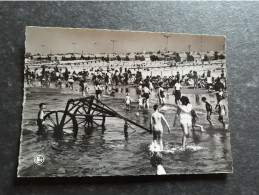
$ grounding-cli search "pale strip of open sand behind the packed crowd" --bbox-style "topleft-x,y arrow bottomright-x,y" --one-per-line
26,60 -> 226,78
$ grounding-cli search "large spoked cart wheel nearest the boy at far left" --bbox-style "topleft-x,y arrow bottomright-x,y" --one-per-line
44,111 -> 78,138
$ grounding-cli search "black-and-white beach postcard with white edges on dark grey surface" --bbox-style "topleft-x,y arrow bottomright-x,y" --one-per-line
17,27 -> 232,177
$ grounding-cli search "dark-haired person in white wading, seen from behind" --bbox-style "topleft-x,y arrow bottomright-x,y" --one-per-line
173,96 -> 192,148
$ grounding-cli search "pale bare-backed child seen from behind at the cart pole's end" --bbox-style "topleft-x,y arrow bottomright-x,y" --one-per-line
150,104 -> 171,150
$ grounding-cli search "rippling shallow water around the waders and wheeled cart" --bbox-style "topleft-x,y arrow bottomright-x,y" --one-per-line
18,80 -> 232,177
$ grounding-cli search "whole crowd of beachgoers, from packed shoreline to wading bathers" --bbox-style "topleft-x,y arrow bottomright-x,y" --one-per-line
30,66 -> 228,149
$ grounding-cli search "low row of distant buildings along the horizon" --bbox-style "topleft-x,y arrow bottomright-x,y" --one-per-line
26,51 -> 225,62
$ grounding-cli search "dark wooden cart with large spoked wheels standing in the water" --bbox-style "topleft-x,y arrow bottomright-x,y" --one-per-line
44,96 -> 150,138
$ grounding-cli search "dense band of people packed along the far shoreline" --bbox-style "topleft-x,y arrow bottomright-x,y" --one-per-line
25,65 -> 224,89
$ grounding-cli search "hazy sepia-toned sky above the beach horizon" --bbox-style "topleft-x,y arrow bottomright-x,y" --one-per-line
25,27 -> 225,54
